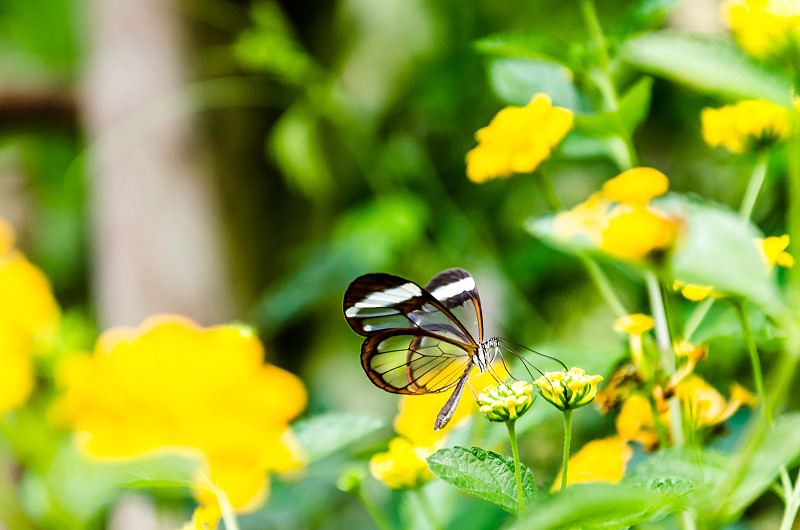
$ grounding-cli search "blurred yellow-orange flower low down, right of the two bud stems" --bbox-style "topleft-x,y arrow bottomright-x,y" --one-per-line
552,436 -> 633,491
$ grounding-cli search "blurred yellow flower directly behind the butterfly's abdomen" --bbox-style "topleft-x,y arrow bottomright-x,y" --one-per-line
394,363 -> 508,447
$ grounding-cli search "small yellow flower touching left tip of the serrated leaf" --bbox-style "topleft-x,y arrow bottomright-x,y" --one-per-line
369,437 -> 433,490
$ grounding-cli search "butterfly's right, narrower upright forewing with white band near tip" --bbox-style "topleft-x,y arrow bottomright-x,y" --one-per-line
425,269 -> 483,342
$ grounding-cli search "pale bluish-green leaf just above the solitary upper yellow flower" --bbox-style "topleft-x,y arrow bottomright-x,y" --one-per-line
489,57 -> 591,111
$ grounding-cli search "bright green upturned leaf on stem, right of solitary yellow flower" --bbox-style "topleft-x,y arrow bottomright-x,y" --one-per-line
575,77 -> 653,138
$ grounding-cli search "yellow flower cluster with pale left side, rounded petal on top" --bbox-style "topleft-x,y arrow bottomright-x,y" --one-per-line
554,167 -> 677,260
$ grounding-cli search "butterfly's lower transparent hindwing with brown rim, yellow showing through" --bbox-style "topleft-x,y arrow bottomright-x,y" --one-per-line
361,329 -> 472,394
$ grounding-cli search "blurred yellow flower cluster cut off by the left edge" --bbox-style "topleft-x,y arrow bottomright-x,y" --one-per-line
0,219 -> 60,414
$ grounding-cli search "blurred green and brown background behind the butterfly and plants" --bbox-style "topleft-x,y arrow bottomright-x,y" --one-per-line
0,0 -> 782,528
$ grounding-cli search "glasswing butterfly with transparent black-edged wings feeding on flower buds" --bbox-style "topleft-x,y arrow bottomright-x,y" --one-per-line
344,269 -> 501,431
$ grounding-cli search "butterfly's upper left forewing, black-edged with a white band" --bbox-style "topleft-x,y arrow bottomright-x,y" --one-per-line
344,274 -> 477,346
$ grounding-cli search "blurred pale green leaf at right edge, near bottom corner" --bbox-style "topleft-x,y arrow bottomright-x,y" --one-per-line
721,412 -> 800,516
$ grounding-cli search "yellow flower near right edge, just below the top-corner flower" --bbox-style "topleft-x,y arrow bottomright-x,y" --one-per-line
700,100 -> 792,153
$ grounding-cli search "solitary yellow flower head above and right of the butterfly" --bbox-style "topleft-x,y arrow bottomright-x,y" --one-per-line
467,94 -> 574,183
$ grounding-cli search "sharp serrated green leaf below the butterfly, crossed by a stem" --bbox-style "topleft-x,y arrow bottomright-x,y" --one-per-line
428,446 -> 536,513
